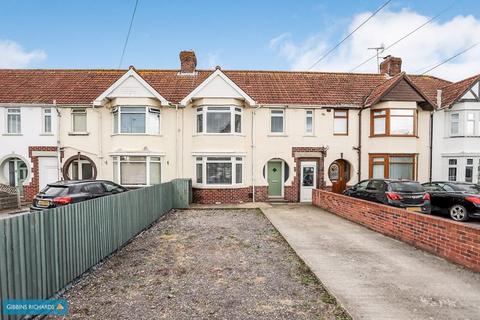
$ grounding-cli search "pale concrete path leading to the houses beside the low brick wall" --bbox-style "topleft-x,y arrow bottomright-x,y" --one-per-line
262,204 -> 480,319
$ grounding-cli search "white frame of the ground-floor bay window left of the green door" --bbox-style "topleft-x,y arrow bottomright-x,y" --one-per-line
194,155 -> 245,188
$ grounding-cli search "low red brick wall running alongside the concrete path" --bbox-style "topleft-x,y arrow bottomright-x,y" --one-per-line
312,190 -> 480,272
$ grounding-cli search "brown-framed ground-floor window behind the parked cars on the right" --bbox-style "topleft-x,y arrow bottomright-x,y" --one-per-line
369,154 -> 416,180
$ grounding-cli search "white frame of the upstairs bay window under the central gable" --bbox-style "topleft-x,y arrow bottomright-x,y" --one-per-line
195,105 -> 244,135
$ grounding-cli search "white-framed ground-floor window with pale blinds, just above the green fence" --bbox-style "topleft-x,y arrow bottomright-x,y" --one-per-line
113,156 -> 162,187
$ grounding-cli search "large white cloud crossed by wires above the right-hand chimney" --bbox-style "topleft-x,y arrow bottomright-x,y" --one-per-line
269,9 -> 480,80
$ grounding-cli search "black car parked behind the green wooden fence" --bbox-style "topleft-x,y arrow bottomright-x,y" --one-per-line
30,180 -> 128,211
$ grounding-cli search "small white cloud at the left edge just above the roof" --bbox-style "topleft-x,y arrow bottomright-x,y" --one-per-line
0,40 -> 47,68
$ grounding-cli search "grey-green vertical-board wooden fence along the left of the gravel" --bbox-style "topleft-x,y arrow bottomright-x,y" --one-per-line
0,179 -> 191,319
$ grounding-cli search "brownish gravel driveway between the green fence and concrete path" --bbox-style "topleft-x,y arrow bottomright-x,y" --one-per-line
51,209 -> 349,319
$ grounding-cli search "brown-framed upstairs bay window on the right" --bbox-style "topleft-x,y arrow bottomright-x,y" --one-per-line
371,109 -> 417,136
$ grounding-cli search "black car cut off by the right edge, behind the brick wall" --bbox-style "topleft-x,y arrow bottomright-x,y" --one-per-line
422,181 -> 480,221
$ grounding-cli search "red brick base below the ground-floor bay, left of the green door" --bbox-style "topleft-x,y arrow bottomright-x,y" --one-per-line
193,186 -> 267,204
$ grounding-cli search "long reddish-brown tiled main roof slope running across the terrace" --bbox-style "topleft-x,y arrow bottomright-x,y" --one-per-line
0,69 -> 450,107
